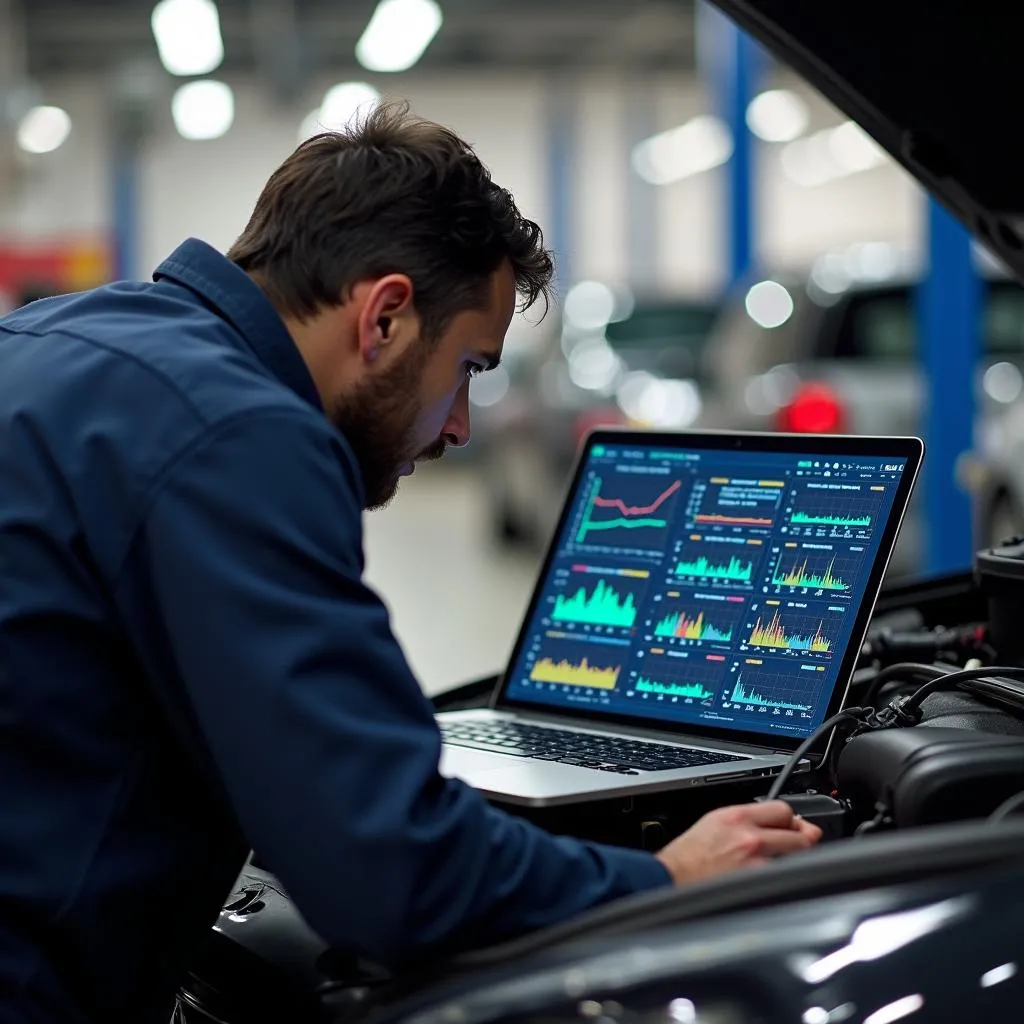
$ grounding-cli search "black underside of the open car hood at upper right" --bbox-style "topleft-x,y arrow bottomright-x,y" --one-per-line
712,0 -> 1024,281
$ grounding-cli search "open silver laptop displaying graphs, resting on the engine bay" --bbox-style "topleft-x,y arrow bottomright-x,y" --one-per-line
437,430 -> 924,806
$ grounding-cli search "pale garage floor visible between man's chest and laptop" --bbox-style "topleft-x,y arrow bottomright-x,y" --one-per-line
366,466 -> 537,693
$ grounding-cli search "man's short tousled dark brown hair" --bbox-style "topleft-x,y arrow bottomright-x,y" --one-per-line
227,102 -> 554,338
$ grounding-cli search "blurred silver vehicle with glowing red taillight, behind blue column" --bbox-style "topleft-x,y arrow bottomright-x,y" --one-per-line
694,244 -> 1024,575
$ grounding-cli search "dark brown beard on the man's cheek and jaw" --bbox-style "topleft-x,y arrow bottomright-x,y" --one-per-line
329,345 -> 447,510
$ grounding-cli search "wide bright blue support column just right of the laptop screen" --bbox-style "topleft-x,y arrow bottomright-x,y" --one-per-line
918,200 -> 982,572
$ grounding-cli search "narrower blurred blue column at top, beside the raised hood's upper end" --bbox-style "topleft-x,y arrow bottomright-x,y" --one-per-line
696,0 -> 766,291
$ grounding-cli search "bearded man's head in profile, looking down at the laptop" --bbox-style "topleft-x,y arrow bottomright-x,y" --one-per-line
228,104 -> 553,508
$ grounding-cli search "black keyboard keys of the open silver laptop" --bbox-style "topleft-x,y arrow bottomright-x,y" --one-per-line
441,722 -> 749,775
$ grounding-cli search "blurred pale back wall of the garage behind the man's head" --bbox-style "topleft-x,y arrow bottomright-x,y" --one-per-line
0,69 -> 923,291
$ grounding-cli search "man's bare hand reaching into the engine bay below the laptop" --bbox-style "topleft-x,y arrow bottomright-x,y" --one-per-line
657,800 -> 821,885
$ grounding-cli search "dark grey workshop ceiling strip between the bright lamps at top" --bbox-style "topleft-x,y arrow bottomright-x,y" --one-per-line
22,0 -> 694,84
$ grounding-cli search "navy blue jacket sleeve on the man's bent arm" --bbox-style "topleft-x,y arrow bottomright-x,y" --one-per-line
123,411 -> 670,964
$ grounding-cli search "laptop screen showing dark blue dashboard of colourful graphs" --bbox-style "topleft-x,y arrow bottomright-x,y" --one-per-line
503,433 -> 921,745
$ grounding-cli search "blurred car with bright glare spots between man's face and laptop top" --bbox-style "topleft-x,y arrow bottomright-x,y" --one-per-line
470,282 -> 718,546
